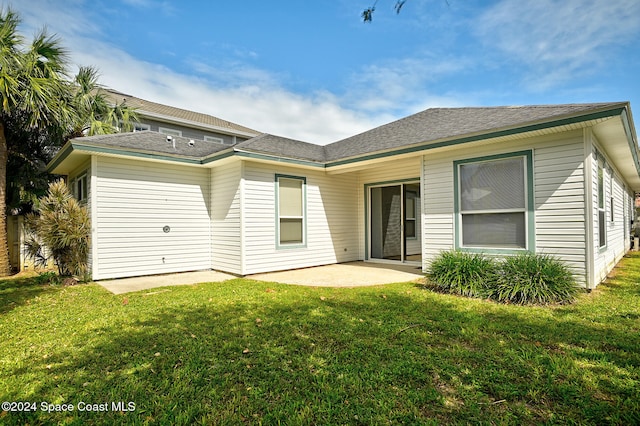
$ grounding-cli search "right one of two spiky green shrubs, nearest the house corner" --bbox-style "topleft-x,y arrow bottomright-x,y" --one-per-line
490,253 -> 580,304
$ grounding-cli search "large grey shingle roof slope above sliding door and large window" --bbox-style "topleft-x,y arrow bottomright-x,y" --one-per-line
325,102 -> 626,161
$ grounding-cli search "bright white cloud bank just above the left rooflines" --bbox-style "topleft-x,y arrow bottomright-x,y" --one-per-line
74,37 -> 382,144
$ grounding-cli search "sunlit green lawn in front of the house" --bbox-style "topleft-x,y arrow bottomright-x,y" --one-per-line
0,254 -> 640,425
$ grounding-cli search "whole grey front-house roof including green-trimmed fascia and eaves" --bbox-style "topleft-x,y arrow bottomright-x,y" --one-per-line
49,102 -> 640,189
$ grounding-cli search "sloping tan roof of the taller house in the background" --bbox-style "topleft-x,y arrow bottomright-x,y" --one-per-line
105,89 -> 261,137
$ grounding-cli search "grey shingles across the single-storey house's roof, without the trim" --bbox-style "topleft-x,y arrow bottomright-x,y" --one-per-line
55,102 -> 628,166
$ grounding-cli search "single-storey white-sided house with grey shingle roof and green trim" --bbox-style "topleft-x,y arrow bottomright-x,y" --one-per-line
49,102 -> 640,288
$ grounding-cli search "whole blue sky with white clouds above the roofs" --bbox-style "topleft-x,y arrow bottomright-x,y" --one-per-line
6,0 -> 640,144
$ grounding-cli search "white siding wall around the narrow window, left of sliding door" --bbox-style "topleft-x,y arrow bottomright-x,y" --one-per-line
242,162 -> 358,274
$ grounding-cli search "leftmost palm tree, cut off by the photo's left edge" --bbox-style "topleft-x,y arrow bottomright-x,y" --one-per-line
0,9 -> 74,276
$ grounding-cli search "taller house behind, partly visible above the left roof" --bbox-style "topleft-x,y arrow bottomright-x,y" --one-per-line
104,89 -> 261,145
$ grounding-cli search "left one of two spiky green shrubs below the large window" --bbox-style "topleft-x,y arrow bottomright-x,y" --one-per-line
427,251 -> 496,297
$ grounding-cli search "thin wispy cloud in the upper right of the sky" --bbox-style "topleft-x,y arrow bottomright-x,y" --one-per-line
476,0 -> 640,89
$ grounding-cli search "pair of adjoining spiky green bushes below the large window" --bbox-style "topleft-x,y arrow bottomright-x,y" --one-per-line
427,251 -> 580,305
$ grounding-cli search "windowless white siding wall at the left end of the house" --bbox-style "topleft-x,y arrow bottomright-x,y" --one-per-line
92,157 -> 211,279
